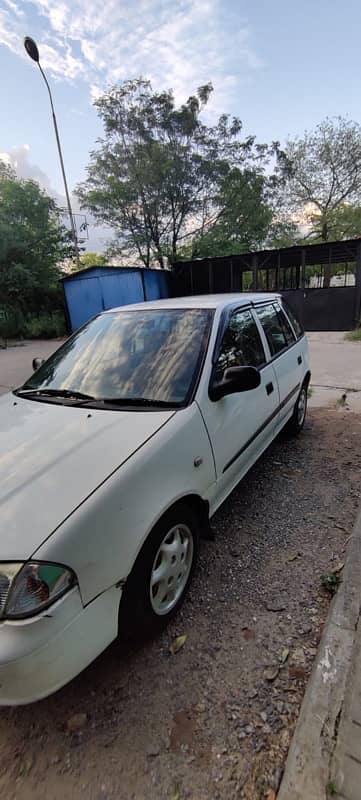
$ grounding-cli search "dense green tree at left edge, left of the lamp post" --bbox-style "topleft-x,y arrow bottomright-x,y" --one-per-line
0,166 -> 73,313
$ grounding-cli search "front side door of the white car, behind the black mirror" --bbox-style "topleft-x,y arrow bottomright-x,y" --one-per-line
199,308 -> 279,510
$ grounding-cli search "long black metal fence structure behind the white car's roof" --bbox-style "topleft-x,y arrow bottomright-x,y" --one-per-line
172,239 -> 361,331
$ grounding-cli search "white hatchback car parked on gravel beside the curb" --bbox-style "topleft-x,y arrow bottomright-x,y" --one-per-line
0,293 -> 310,705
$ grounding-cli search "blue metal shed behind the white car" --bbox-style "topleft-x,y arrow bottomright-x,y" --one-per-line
62,267 -> 169,331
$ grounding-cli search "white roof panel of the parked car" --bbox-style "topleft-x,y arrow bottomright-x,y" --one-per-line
106,292 -> 280,313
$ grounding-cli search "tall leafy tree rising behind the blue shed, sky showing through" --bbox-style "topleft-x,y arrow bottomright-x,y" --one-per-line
78,79 -> 268,267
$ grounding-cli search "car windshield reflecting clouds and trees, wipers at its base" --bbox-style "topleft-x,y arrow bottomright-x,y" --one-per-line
20,308 -> 213,406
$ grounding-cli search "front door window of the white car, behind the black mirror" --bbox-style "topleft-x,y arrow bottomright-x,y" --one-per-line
214,311 -> 266,380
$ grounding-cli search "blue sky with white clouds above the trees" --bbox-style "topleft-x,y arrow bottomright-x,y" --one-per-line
0,0 -> 361,249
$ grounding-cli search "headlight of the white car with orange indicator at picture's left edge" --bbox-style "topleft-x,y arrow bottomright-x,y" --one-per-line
0,561 -> 76,619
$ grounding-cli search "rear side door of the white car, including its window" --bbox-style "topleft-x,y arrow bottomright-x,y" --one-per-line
255,300 -> 303,427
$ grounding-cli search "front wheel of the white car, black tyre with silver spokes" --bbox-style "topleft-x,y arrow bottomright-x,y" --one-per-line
119,503 -> 200,640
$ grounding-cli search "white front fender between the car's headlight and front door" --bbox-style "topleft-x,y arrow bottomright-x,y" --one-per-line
33,402 -> 216,604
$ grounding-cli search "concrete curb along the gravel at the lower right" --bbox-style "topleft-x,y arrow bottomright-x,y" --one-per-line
277,511 -> 361,800
